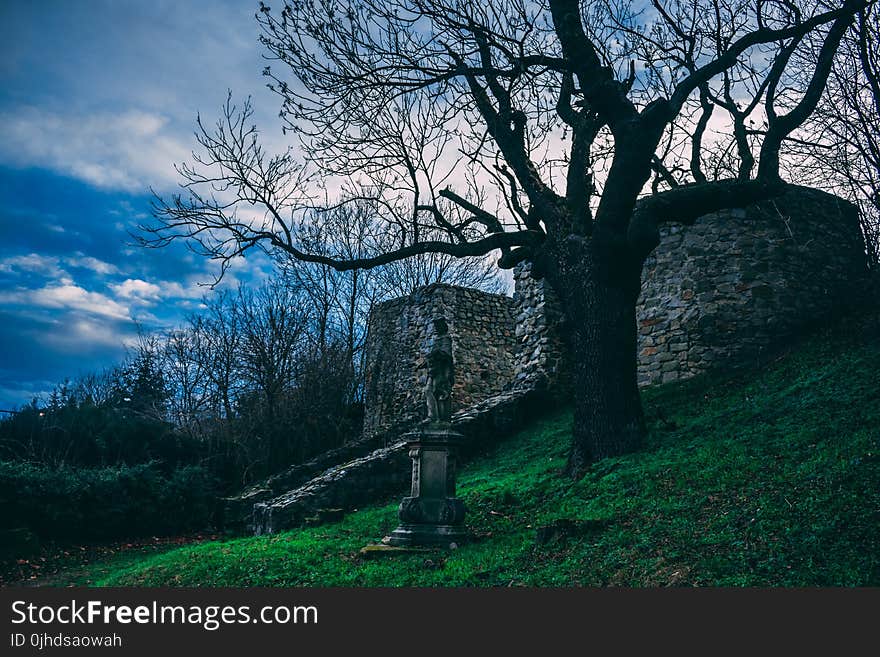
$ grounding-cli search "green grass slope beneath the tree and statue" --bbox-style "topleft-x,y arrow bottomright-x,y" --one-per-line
56,316 -> 880,586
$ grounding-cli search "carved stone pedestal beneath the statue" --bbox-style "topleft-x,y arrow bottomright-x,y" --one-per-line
387,424 -> 468,547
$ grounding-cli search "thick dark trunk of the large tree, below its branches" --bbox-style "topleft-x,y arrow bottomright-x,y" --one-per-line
547,237 -> 645,477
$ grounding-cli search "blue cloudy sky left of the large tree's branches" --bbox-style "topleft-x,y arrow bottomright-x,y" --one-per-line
0,0 -> 278,409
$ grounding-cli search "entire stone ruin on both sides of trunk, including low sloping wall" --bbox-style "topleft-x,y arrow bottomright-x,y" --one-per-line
246,189 -> 867,533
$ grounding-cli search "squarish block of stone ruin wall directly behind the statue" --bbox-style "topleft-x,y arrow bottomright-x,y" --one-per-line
364,283 -> 515,439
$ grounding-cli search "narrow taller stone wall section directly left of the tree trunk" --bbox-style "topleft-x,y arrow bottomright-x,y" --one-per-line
511,262 -> 566,390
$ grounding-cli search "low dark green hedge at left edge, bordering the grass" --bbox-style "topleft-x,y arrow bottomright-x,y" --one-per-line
0,461 -> 217,541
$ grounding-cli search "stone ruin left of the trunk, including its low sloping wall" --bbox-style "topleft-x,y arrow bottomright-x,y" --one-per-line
230,272 -> 564,532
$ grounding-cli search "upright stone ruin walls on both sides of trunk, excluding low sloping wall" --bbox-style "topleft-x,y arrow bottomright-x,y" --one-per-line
364,188 -> 867,435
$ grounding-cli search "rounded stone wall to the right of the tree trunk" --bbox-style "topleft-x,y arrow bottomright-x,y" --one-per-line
637,182 -> 867,386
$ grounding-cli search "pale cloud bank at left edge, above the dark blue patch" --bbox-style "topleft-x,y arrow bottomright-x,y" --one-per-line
0,107 -> 190,192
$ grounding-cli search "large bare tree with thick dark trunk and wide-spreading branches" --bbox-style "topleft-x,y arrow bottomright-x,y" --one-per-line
144,0 -> 869,475
